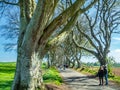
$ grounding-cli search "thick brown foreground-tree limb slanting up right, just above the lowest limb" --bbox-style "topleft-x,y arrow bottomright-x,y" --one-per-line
41,0 -> 84,39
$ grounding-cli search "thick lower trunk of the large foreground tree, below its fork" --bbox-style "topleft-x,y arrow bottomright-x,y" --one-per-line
12,47 -> 44,90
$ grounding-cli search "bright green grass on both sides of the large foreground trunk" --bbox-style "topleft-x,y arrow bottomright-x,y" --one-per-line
0,62 -> 62,90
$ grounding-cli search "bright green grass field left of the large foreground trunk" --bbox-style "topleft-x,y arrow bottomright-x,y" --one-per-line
0,62 -> 16,90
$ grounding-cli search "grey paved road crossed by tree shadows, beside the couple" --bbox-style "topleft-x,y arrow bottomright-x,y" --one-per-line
59,69 -> 120,90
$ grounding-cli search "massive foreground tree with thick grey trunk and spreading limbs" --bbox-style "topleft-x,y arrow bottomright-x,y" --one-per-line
0,0 -> 97,90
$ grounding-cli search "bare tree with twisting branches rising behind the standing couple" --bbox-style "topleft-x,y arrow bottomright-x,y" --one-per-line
74,0 -> 120,65
